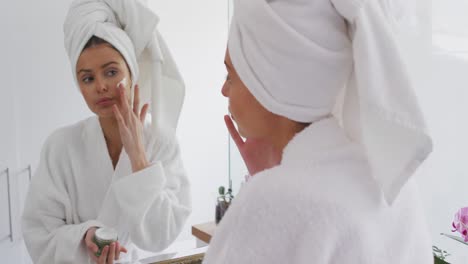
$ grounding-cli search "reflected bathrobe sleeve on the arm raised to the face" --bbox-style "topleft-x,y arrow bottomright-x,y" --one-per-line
98,131 -> 191,251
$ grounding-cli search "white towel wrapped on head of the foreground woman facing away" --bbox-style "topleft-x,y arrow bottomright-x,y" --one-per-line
228,0 -> 432,203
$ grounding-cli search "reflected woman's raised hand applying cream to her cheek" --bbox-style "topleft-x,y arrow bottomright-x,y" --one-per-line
113,83 -> 149,172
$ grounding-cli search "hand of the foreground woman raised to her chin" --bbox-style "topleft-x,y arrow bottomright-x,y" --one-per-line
224,115 -> 281,176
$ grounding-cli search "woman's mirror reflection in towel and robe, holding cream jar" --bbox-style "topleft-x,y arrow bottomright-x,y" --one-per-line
23,0 -> 191,263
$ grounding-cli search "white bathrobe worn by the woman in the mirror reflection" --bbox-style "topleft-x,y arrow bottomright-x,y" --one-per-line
23,117 -> 191,264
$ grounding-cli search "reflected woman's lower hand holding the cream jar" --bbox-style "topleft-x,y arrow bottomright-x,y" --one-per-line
84,227 -> 127,264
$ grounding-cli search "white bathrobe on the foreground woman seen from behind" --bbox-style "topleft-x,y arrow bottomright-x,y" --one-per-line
204,118 -> 433,264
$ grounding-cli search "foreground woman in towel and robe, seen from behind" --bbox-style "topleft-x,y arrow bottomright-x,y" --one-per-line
204,0 -> 433,264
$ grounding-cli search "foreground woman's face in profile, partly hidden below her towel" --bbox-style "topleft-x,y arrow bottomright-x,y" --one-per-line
221,51 -> 278,138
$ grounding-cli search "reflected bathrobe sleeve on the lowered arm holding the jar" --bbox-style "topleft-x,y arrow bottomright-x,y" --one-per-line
22,132 -> 102,264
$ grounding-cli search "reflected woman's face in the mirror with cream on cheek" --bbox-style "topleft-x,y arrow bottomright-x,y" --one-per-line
76,44 -> 131,118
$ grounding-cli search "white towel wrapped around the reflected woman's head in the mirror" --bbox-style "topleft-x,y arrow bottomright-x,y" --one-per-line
64,0 -> 185,131
